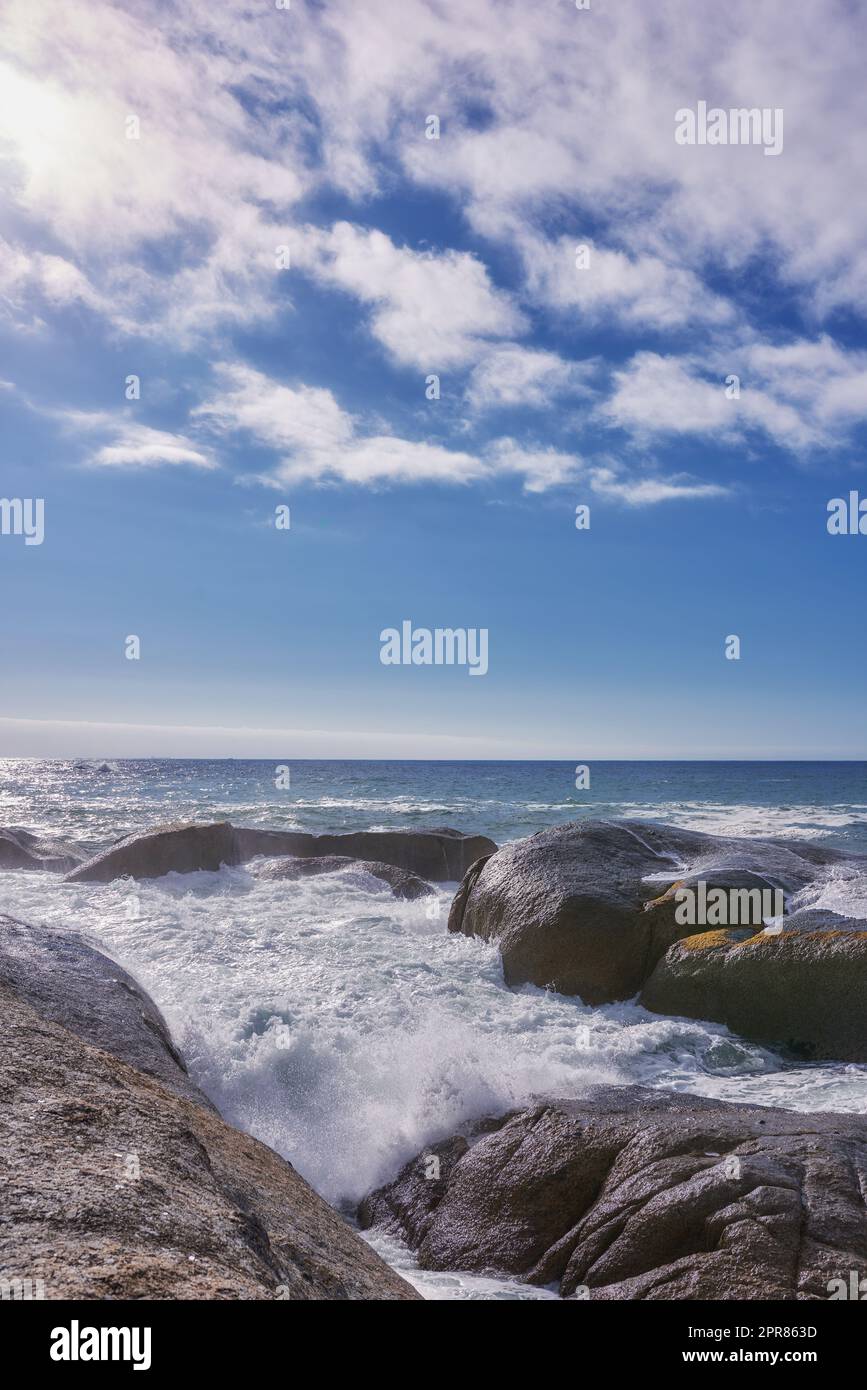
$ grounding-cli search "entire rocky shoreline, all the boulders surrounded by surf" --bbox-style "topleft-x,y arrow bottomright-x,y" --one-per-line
0,821 -> 867,1300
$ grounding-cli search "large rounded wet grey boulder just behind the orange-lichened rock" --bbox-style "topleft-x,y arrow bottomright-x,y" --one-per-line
449,821 -> 855,1004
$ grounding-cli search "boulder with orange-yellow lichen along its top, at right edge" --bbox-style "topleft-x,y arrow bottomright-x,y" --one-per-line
641,912 -> 867,1062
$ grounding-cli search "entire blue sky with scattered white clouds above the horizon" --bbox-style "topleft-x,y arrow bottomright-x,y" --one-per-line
0,0 -> 867,760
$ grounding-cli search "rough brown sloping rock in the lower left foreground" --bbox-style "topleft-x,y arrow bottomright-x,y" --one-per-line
0,923 -> 418,1300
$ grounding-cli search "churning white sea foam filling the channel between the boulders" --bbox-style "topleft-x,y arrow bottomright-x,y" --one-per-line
0,869 -> 867,1228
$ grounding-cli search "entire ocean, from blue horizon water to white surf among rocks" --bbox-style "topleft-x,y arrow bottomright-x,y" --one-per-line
0,759 -> 867,1300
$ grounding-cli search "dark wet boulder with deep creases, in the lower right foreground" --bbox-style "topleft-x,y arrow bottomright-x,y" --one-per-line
361,1087 -> 867,1300
